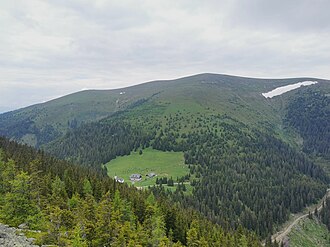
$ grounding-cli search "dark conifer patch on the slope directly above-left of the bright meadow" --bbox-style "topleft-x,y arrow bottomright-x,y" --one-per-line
45,119 -> 154,169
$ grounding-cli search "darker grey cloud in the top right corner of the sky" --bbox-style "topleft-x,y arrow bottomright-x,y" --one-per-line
228,0 -> 330,32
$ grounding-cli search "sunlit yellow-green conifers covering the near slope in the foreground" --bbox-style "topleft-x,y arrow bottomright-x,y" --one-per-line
0,138 -> 260,246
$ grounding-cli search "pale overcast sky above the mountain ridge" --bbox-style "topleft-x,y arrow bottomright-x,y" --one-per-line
0,0 -> 330,112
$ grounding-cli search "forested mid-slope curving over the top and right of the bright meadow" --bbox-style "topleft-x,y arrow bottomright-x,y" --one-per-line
48,102 -> 328,237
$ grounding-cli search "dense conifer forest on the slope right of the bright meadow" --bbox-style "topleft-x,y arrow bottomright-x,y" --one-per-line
153,113 -> 327,236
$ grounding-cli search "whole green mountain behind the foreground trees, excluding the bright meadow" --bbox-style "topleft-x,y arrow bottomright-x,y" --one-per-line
0,74 -> 330,243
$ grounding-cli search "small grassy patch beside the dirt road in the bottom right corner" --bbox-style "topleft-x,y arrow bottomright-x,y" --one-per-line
289,218 -> 330,247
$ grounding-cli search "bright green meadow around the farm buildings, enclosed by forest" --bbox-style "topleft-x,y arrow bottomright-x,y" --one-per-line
105,148 -> 189,187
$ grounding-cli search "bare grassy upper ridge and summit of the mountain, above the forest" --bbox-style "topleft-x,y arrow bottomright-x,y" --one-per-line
0,74 -> 328,147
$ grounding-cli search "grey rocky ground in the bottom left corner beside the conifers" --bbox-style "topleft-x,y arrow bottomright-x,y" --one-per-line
0,224 -> 38,247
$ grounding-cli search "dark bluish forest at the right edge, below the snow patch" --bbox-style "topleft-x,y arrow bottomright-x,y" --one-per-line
285,89 -> 330,159
